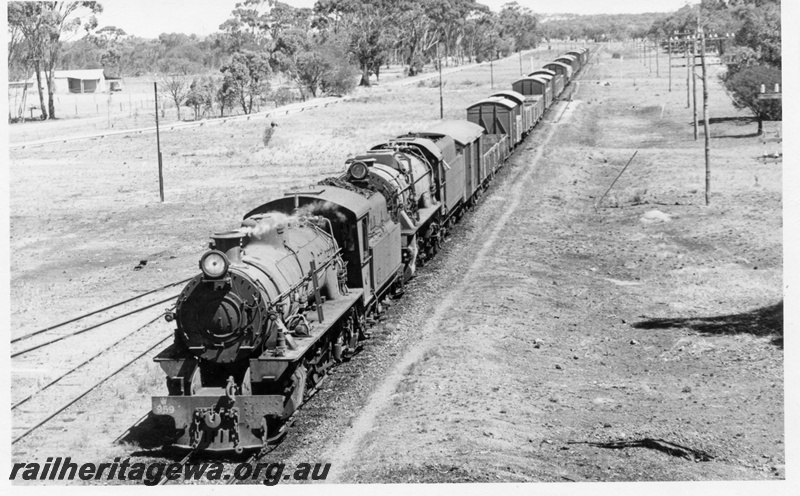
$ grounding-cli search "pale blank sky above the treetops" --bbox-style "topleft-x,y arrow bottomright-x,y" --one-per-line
98,0 -> 699,38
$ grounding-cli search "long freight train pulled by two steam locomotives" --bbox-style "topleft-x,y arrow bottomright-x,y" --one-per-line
152,49 -> 589,453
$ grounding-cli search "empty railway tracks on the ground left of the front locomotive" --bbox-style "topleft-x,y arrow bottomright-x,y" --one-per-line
11,279 -> 188,444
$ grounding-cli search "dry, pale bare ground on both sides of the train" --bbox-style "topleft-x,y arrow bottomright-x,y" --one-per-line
11,47 -> 785,482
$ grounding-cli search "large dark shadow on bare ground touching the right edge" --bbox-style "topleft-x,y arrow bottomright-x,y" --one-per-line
633,300 -> 783,348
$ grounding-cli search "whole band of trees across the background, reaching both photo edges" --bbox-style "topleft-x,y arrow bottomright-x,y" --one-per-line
8,0 -> 781,126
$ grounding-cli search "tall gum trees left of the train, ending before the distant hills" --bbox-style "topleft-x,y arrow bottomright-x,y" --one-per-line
8,0 -> 538,119
